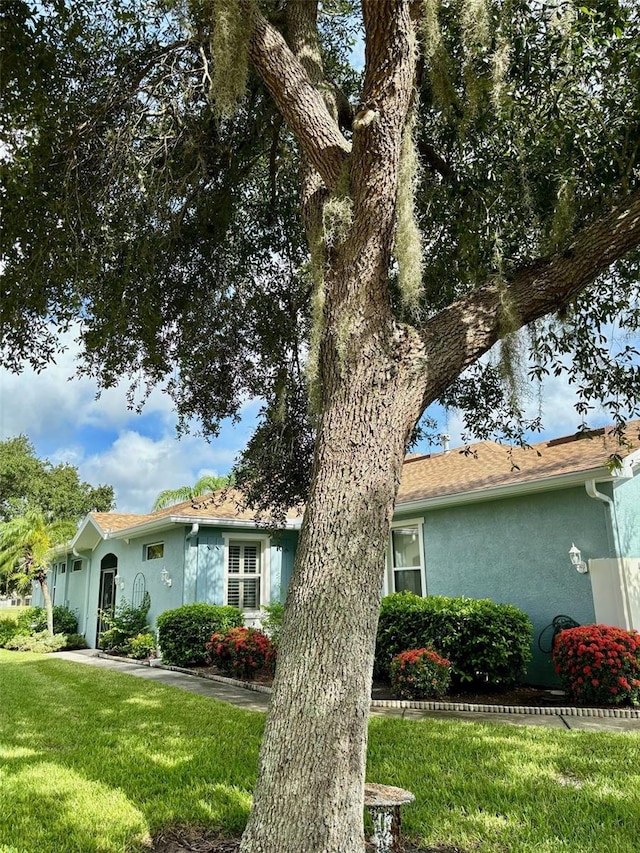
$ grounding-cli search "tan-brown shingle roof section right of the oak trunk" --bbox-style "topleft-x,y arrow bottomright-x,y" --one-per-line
396,421 -> 640,504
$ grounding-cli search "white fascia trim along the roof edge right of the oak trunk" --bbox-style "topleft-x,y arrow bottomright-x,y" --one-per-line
395,468 -> 629,513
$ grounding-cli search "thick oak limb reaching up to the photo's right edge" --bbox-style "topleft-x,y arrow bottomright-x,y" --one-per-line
422,189 -> 640,400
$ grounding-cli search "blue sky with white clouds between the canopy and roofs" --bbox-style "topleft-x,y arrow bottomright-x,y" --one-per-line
0,324 -> 610,513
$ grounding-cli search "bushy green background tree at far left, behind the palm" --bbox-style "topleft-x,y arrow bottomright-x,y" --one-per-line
0,435 -> 115,522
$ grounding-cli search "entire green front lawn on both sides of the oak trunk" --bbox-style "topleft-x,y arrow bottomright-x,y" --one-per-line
0,651 -> 640,853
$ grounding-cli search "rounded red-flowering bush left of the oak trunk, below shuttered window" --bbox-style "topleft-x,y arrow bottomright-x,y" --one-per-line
205,628 -> 276,678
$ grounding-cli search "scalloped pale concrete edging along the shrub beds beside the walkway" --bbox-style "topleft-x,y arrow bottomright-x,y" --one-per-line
96,652 -> 640,720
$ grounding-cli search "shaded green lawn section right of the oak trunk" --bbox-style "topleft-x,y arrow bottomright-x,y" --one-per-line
368,719 -> 640,853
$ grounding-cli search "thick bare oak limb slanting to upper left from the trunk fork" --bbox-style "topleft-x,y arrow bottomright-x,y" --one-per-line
249,2 -> 351,189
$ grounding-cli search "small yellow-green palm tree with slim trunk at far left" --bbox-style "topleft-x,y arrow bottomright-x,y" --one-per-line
0,508 -> 76,634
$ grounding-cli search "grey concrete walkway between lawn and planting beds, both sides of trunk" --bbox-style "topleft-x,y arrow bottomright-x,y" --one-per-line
51,649 -> 640,734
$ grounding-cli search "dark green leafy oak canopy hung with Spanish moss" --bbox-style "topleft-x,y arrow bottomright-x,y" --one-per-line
0,0 -> 640,502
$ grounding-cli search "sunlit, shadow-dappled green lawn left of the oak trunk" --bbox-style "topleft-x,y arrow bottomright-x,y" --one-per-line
0,657 -> 264,853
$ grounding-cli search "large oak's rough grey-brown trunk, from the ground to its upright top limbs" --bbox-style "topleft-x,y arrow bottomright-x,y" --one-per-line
241,0 -> 424,853
